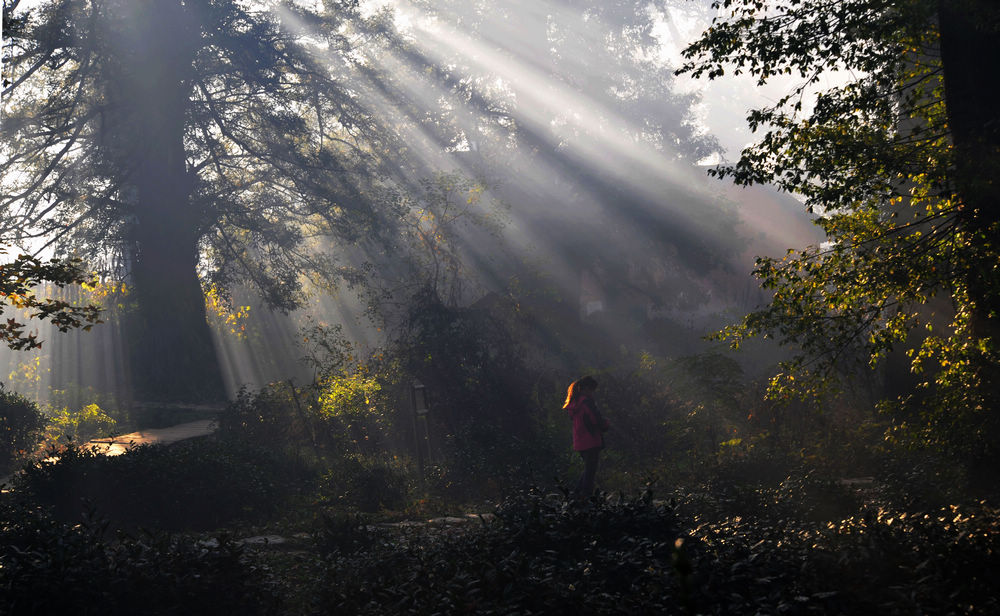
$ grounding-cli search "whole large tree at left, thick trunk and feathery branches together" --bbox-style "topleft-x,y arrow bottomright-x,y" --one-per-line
0,0 -> 400,398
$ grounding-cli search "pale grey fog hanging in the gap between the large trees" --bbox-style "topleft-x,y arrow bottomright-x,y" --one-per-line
0,1 -> 819,399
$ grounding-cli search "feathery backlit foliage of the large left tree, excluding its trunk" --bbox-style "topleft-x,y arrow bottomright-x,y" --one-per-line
2,0 -> 394,300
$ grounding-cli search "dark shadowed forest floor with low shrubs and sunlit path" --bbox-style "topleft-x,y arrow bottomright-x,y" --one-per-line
0,415 -> 1000,616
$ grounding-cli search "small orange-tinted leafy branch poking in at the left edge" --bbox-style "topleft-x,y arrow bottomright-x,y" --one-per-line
0,248 -> 101,350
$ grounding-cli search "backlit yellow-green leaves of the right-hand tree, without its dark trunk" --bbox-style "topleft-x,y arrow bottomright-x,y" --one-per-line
681,0 -> 1000,452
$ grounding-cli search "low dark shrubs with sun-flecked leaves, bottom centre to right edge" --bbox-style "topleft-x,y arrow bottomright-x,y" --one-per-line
313,482 -> 1000,614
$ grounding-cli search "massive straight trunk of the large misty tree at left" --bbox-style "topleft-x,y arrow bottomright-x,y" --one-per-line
121,0 -> 225,401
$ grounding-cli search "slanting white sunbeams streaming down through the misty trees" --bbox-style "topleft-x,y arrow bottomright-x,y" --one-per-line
0,0 -> 815,404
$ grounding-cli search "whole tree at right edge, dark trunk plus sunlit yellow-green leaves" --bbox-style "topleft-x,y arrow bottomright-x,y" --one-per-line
681,0 -> 1000,458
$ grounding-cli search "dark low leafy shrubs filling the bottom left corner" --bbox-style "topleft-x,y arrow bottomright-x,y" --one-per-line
0,494 -> 279,615
